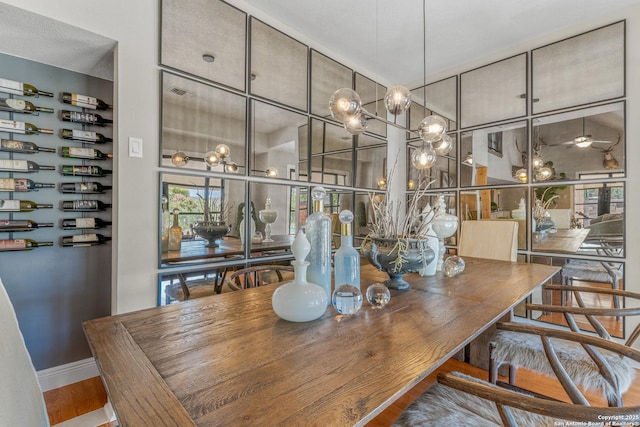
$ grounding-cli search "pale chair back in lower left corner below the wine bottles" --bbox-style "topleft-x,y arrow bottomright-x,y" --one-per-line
0,280 -> 49,426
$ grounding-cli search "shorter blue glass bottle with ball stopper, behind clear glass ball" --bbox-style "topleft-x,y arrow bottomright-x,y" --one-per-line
333,209 -> 360,289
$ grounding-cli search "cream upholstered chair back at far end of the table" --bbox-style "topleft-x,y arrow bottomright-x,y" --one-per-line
458,220 -> 518,262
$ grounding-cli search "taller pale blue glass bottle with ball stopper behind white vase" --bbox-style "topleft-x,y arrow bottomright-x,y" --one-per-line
305,187 -> 331,303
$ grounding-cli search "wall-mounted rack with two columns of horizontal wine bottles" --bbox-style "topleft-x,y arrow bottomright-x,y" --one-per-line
0,76 -> 113,253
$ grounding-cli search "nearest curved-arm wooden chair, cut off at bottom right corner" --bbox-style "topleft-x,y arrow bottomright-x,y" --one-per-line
394,323 -> 640,427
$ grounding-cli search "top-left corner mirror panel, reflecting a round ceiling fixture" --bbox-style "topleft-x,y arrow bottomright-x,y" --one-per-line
160,0 -> 247,90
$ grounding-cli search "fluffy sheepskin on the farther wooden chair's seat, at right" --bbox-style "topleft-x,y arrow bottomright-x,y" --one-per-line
490,331 -> 635,399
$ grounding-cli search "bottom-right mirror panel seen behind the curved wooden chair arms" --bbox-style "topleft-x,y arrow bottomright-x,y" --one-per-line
531,256 -> 629,338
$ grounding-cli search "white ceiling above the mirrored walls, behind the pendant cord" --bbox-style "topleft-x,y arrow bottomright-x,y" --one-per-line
241,0 -> 640,85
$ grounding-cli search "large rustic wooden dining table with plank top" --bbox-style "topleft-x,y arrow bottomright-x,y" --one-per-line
83,258 -> 558,427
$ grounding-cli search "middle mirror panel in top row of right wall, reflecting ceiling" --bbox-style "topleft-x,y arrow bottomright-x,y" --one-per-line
460,53 -> 527,129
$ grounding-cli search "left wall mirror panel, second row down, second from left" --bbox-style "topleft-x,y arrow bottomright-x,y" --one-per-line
249,100 -> 308,179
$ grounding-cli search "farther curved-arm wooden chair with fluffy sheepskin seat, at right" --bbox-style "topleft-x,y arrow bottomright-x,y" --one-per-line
489,285 -> 640,406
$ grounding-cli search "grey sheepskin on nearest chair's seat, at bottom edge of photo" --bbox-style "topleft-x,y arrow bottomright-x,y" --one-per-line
393,373 -> 562,427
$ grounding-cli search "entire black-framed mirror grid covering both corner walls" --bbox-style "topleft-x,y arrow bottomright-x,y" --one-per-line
159,0 -> 627,336
